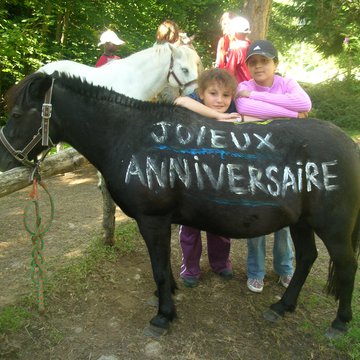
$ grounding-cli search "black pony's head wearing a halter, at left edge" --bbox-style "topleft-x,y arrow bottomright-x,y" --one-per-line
0,73 -> 52,171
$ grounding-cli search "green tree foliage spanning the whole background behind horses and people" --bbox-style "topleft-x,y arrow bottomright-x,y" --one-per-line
0,0 -> 360,125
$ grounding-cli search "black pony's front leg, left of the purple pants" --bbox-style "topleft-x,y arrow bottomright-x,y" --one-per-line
136,215 -> 176,335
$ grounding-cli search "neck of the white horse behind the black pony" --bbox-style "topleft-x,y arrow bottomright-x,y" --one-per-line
93,47 -> 171,100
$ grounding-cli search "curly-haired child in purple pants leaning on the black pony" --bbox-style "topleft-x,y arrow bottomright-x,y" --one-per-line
175,68 -> 240,287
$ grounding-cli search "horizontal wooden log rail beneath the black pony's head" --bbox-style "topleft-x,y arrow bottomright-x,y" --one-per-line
0,148 -> 89,198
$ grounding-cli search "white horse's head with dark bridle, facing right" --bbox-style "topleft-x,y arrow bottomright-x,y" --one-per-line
168,44 -> 202,95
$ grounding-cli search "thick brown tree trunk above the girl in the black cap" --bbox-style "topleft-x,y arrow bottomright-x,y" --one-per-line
241,0 -> 272,41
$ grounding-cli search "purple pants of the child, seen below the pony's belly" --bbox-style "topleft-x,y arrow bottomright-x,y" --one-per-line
180,225 -> 231,278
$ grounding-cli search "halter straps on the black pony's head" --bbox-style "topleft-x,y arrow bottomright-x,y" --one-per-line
0,79 -> 54,167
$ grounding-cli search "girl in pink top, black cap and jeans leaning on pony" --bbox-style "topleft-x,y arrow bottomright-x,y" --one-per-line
235,40 -> 311,293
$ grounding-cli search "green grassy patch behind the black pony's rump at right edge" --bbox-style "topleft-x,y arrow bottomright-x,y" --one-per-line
303,78 -> 360,133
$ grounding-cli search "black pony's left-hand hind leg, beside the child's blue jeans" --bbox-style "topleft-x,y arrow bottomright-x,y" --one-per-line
264,221 -> 317,321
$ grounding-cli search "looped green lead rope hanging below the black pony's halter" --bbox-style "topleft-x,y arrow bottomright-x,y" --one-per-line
23,174 -> 54,313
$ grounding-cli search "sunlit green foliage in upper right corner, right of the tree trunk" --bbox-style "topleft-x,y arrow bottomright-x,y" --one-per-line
270,0 -> 360,76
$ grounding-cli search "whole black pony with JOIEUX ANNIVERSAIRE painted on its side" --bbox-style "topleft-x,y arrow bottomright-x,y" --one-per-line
0,73 -> 360,335
